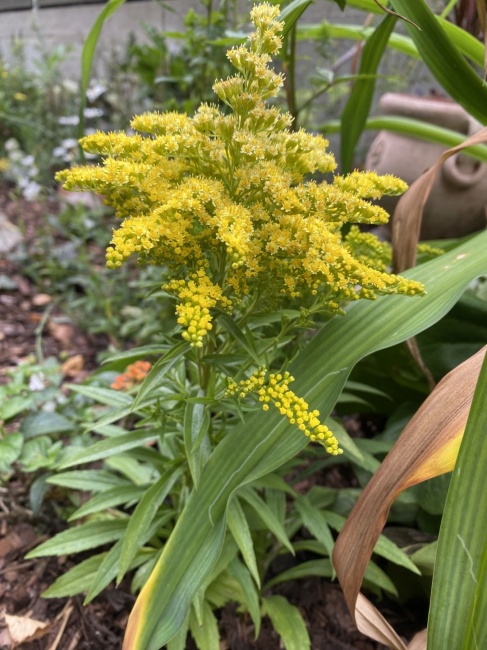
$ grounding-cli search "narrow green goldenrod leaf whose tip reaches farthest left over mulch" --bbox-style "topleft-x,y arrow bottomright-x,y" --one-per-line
26,519 -> 127,559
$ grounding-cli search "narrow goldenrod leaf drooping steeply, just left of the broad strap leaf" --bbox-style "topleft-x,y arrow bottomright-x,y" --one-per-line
117,468 -> 182,582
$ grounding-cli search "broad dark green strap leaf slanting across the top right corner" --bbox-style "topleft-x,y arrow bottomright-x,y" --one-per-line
392,0 -> 487,124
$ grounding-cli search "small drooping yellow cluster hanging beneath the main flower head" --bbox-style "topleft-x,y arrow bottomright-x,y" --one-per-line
163,270 -> 231,348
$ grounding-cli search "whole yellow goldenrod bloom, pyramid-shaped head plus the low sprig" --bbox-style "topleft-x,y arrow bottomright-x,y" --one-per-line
57,3 -> 423,453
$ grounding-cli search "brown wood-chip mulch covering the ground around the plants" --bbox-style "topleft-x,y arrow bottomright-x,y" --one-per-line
0,188 -> 420,650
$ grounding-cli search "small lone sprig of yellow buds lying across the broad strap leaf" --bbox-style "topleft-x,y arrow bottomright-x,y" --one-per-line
225,368 -> 343,456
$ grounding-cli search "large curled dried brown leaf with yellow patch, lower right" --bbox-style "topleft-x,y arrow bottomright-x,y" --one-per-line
333,346 -> 487,650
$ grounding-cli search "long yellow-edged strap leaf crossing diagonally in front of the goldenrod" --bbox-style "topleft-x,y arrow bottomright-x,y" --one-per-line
124,232 -> 487,650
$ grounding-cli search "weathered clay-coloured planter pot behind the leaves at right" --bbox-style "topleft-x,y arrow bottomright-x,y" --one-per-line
365,93 -> 487,239
